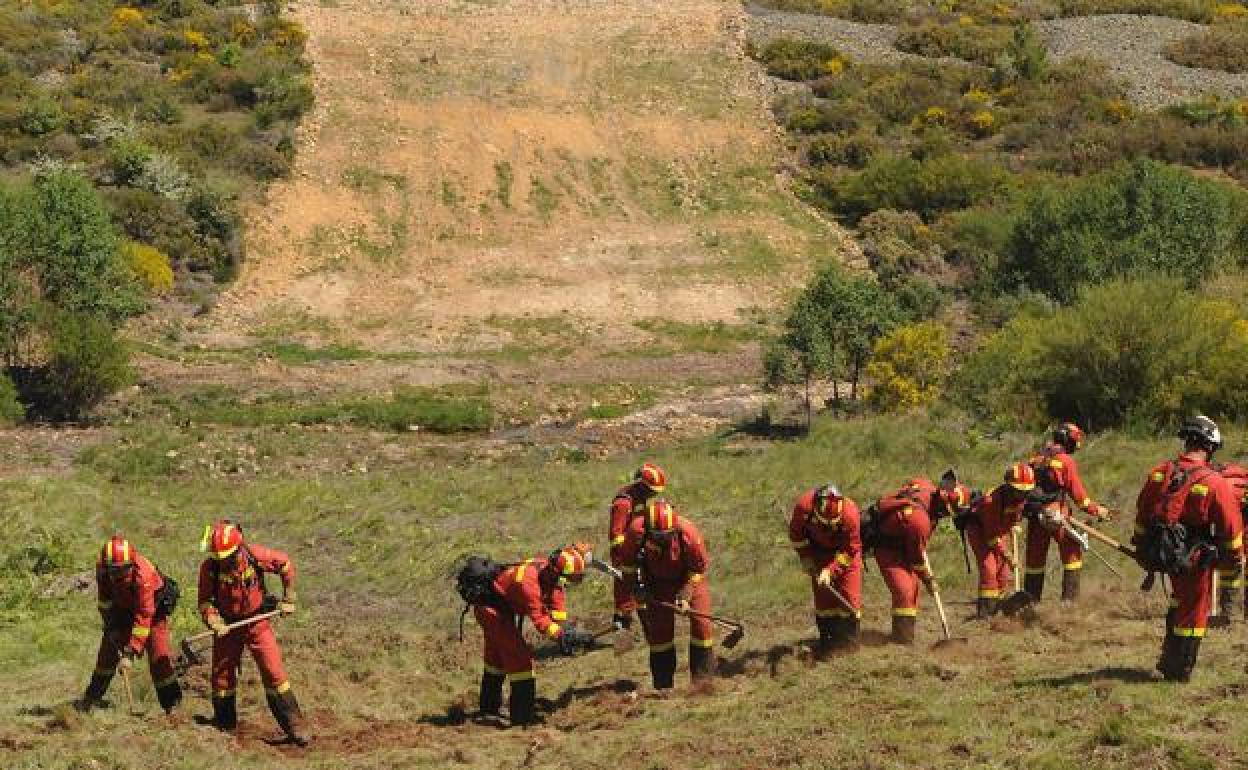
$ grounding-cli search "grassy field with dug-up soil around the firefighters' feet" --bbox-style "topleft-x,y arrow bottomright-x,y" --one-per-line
7,417 -> 1248,769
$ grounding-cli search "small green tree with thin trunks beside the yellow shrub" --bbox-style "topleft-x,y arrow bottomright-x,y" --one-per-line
764,265 -> 902,427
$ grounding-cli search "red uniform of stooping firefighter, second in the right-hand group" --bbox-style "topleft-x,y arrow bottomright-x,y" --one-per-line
875,478 -> 938,618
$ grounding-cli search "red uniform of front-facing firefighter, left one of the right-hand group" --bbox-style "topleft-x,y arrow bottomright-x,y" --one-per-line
789,489 -> 862,618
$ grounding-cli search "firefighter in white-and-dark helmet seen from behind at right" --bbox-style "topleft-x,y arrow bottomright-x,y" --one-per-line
1132,416 -> 1244,681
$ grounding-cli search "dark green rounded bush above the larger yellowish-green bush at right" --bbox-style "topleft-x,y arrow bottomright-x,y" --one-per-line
1000,161 -> 1248,302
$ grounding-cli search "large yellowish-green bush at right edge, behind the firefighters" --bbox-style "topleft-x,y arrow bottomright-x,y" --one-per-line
957,278 -> 1248,429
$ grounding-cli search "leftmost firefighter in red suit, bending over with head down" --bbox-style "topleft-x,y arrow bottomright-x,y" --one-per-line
77,535 -> 182,714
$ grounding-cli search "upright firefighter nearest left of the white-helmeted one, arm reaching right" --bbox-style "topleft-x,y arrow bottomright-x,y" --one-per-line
1023,423 -> 1108,602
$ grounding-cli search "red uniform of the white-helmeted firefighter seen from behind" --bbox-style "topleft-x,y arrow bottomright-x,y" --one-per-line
1133,453 -> 1244,639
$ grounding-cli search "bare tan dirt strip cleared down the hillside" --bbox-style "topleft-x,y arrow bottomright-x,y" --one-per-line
206,0 -> 827,352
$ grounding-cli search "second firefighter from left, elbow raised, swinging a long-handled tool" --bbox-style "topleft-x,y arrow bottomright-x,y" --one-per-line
198,520 -> 306,745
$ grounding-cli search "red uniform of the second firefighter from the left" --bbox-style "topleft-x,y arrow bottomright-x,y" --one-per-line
198,543 -> 295,698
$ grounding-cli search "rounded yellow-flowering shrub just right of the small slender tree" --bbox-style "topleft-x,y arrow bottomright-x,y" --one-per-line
866,321 -> 951,412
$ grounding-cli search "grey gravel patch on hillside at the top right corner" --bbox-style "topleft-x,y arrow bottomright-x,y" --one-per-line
1036,15 -> 1248,109
